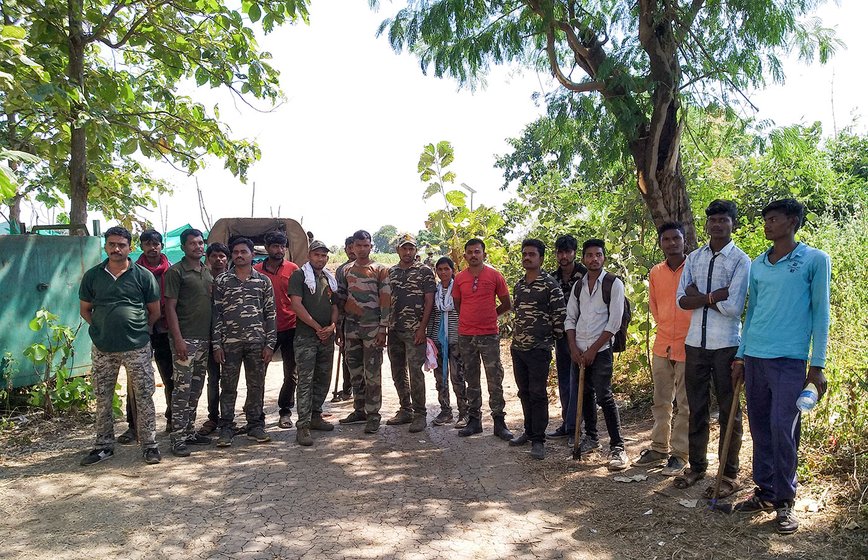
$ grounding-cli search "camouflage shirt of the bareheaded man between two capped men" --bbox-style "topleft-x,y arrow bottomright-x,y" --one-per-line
337,262 -> 392,330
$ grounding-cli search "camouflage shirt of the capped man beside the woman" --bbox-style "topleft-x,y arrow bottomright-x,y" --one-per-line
389,262 -> 437,332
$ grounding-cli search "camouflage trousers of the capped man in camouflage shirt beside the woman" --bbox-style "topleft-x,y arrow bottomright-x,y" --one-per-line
387,330 -> 427,416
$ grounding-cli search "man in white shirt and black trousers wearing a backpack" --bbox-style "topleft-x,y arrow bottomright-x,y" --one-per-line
564,239 -> 630,471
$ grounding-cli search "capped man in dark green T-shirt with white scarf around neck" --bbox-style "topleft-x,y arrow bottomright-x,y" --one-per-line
289,241 -> 338,446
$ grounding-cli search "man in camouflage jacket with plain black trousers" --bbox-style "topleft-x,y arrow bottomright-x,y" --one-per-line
509,239 -> 567,459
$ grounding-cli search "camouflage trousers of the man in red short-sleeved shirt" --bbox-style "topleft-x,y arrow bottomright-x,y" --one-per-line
458,334 -> 506,419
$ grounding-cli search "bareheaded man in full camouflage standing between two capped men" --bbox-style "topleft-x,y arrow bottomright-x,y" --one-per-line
337,230 -> 391,434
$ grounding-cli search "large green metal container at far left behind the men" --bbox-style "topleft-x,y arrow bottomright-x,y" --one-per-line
0,235 -> 104,387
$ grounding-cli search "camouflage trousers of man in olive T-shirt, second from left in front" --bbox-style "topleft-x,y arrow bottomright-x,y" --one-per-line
169,338 -> 211,443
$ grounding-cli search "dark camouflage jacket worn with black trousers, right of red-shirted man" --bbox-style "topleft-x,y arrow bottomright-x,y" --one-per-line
512,272 -> 567,350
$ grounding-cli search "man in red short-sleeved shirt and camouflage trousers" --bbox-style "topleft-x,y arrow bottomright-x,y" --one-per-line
452,238 -> 512,441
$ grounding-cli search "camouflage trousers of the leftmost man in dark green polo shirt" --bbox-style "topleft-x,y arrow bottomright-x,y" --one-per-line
91,344 -> 157,449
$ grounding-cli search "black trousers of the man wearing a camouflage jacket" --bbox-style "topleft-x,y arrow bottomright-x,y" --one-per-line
510,348 -> 552,442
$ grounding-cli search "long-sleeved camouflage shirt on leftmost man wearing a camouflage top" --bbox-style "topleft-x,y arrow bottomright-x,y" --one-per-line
211,270 -> 277,350
